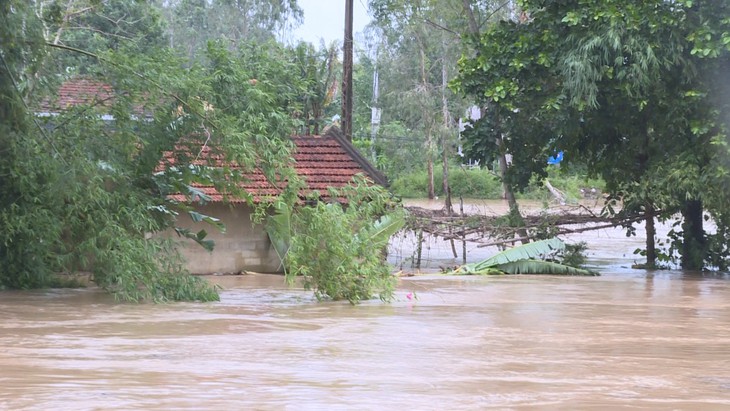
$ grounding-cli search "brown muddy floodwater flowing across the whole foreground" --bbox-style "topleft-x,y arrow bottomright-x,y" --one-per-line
0,269 -> 730,410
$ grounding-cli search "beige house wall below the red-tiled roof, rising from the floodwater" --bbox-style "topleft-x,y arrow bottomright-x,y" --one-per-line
171,203 -> 281,274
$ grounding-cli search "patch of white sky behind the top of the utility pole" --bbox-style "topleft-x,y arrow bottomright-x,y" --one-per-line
292,0 -> 370,46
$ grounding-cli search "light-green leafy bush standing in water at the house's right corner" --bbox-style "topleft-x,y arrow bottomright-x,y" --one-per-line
278,178 -> 405,304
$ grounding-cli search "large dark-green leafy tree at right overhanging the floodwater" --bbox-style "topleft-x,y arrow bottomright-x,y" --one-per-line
455,1 -> 728,268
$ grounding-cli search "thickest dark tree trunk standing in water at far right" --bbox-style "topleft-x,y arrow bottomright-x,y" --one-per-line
681,200 -> 707,270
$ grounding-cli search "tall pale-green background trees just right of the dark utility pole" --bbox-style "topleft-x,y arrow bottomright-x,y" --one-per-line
368,0 -> 470,198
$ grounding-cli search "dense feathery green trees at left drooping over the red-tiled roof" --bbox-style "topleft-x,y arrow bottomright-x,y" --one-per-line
0,0 -> 298,301
